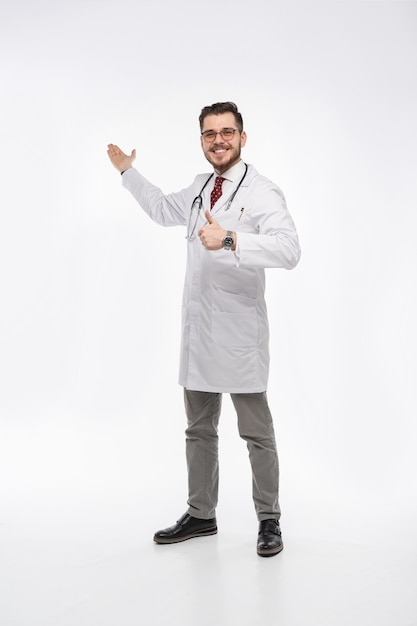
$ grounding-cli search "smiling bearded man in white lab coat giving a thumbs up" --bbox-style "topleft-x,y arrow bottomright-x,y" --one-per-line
108,102 -> 300,556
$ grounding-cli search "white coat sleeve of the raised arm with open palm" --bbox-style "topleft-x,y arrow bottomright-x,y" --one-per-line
122,167 -> 192,226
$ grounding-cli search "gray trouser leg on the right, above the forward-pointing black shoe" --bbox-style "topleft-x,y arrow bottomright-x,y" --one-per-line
231,392 -> 281,521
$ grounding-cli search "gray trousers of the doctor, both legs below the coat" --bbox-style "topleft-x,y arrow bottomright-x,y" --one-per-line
184,389 -> 281,521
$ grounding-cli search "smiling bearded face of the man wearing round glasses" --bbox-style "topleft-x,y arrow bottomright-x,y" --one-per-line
201,113 -> 246,174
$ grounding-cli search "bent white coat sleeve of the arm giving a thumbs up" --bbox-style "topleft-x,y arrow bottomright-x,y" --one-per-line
235,185 -> 301,269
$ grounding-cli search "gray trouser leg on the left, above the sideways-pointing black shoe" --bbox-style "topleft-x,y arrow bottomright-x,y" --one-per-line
184,389 -> 222,519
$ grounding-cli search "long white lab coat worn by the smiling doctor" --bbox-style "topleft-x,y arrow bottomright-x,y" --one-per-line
122,165 -> 300,393
